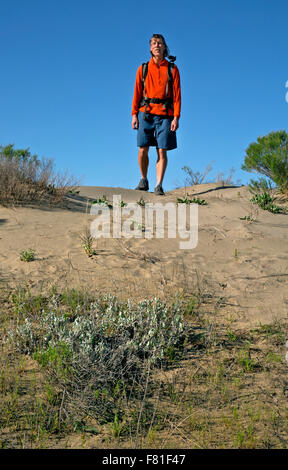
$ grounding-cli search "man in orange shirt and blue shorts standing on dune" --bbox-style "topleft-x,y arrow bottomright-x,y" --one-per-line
132,34 -> 181,196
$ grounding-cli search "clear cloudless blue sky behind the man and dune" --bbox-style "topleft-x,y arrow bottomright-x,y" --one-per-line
0,0 -> 288,190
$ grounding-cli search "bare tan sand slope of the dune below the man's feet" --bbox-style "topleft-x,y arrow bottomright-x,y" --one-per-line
0,184 -> 288,325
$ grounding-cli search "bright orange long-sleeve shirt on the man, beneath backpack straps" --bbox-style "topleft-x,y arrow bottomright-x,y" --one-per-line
132,57 -> 181,117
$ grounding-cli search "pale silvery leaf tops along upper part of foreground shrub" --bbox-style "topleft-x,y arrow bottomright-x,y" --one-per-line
10,296 -> 185,363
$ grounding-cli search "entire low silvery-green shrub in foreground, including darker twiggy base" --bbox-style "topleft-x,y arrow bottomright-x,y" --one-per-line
10,295 -> 186,424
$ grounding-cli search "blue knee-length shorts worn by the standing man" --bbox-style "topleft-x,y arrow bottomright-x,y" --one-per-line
137,111 -> 177,150
